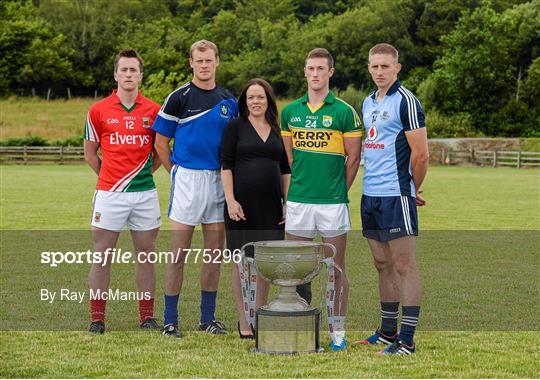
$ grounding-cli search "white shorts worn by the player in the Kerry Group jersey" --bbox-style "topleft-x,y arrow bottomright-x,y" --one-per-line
285,201 -> 351,238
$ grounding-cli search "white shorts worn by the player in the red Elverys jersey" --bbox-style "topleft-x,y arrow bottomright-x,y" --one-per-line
91,189 -> 161,231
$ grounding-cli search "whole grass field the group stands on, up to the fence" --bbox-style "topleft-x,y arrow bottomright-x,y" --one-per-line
0,165 -> 540,378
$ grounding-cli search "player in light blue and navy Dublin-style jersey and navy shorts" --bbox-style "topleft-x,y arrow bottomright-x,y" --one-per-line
359,44 -> 428,355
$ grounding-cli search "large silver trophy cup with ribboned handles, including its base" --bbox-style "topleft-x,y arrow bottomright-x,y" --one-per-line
239,240 -> 336,354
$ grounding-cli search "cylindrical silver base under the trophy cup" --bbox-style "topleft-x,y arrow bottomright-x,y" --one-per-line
254,309 -> 321,354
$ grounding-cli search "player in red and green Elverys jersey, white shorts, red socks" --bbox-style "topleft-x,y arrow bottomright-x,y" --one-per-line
84,49 -> 161,334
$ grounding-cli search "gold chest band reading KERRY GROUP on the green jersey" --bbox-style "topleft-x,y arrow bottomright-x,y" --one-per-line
289,125 -> 345,156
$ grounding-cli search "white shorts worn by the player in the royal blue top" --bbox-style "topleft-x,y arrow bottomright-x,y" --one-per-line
169,165 -> 225,226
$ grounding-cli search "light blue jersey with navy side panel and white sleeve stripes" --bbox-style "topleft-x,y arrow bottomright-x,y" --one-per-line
362,81 -> 425,197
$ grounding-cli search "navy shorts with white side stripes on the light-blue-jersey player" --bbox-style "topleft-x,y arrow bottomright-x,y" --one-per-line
360,195 -> 418,242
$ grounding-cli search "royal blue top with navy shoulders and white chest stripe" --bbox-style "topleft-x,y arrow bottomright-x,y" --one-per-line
152,82 -> 238,170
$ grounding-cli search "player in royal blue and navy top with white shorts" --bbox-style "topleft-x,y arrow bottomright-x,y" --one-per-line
152,40 -> 238,337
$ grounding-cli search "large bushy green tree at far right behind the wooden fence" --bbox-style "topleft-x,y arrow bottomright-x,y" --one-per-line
424,1 -> 540,136
